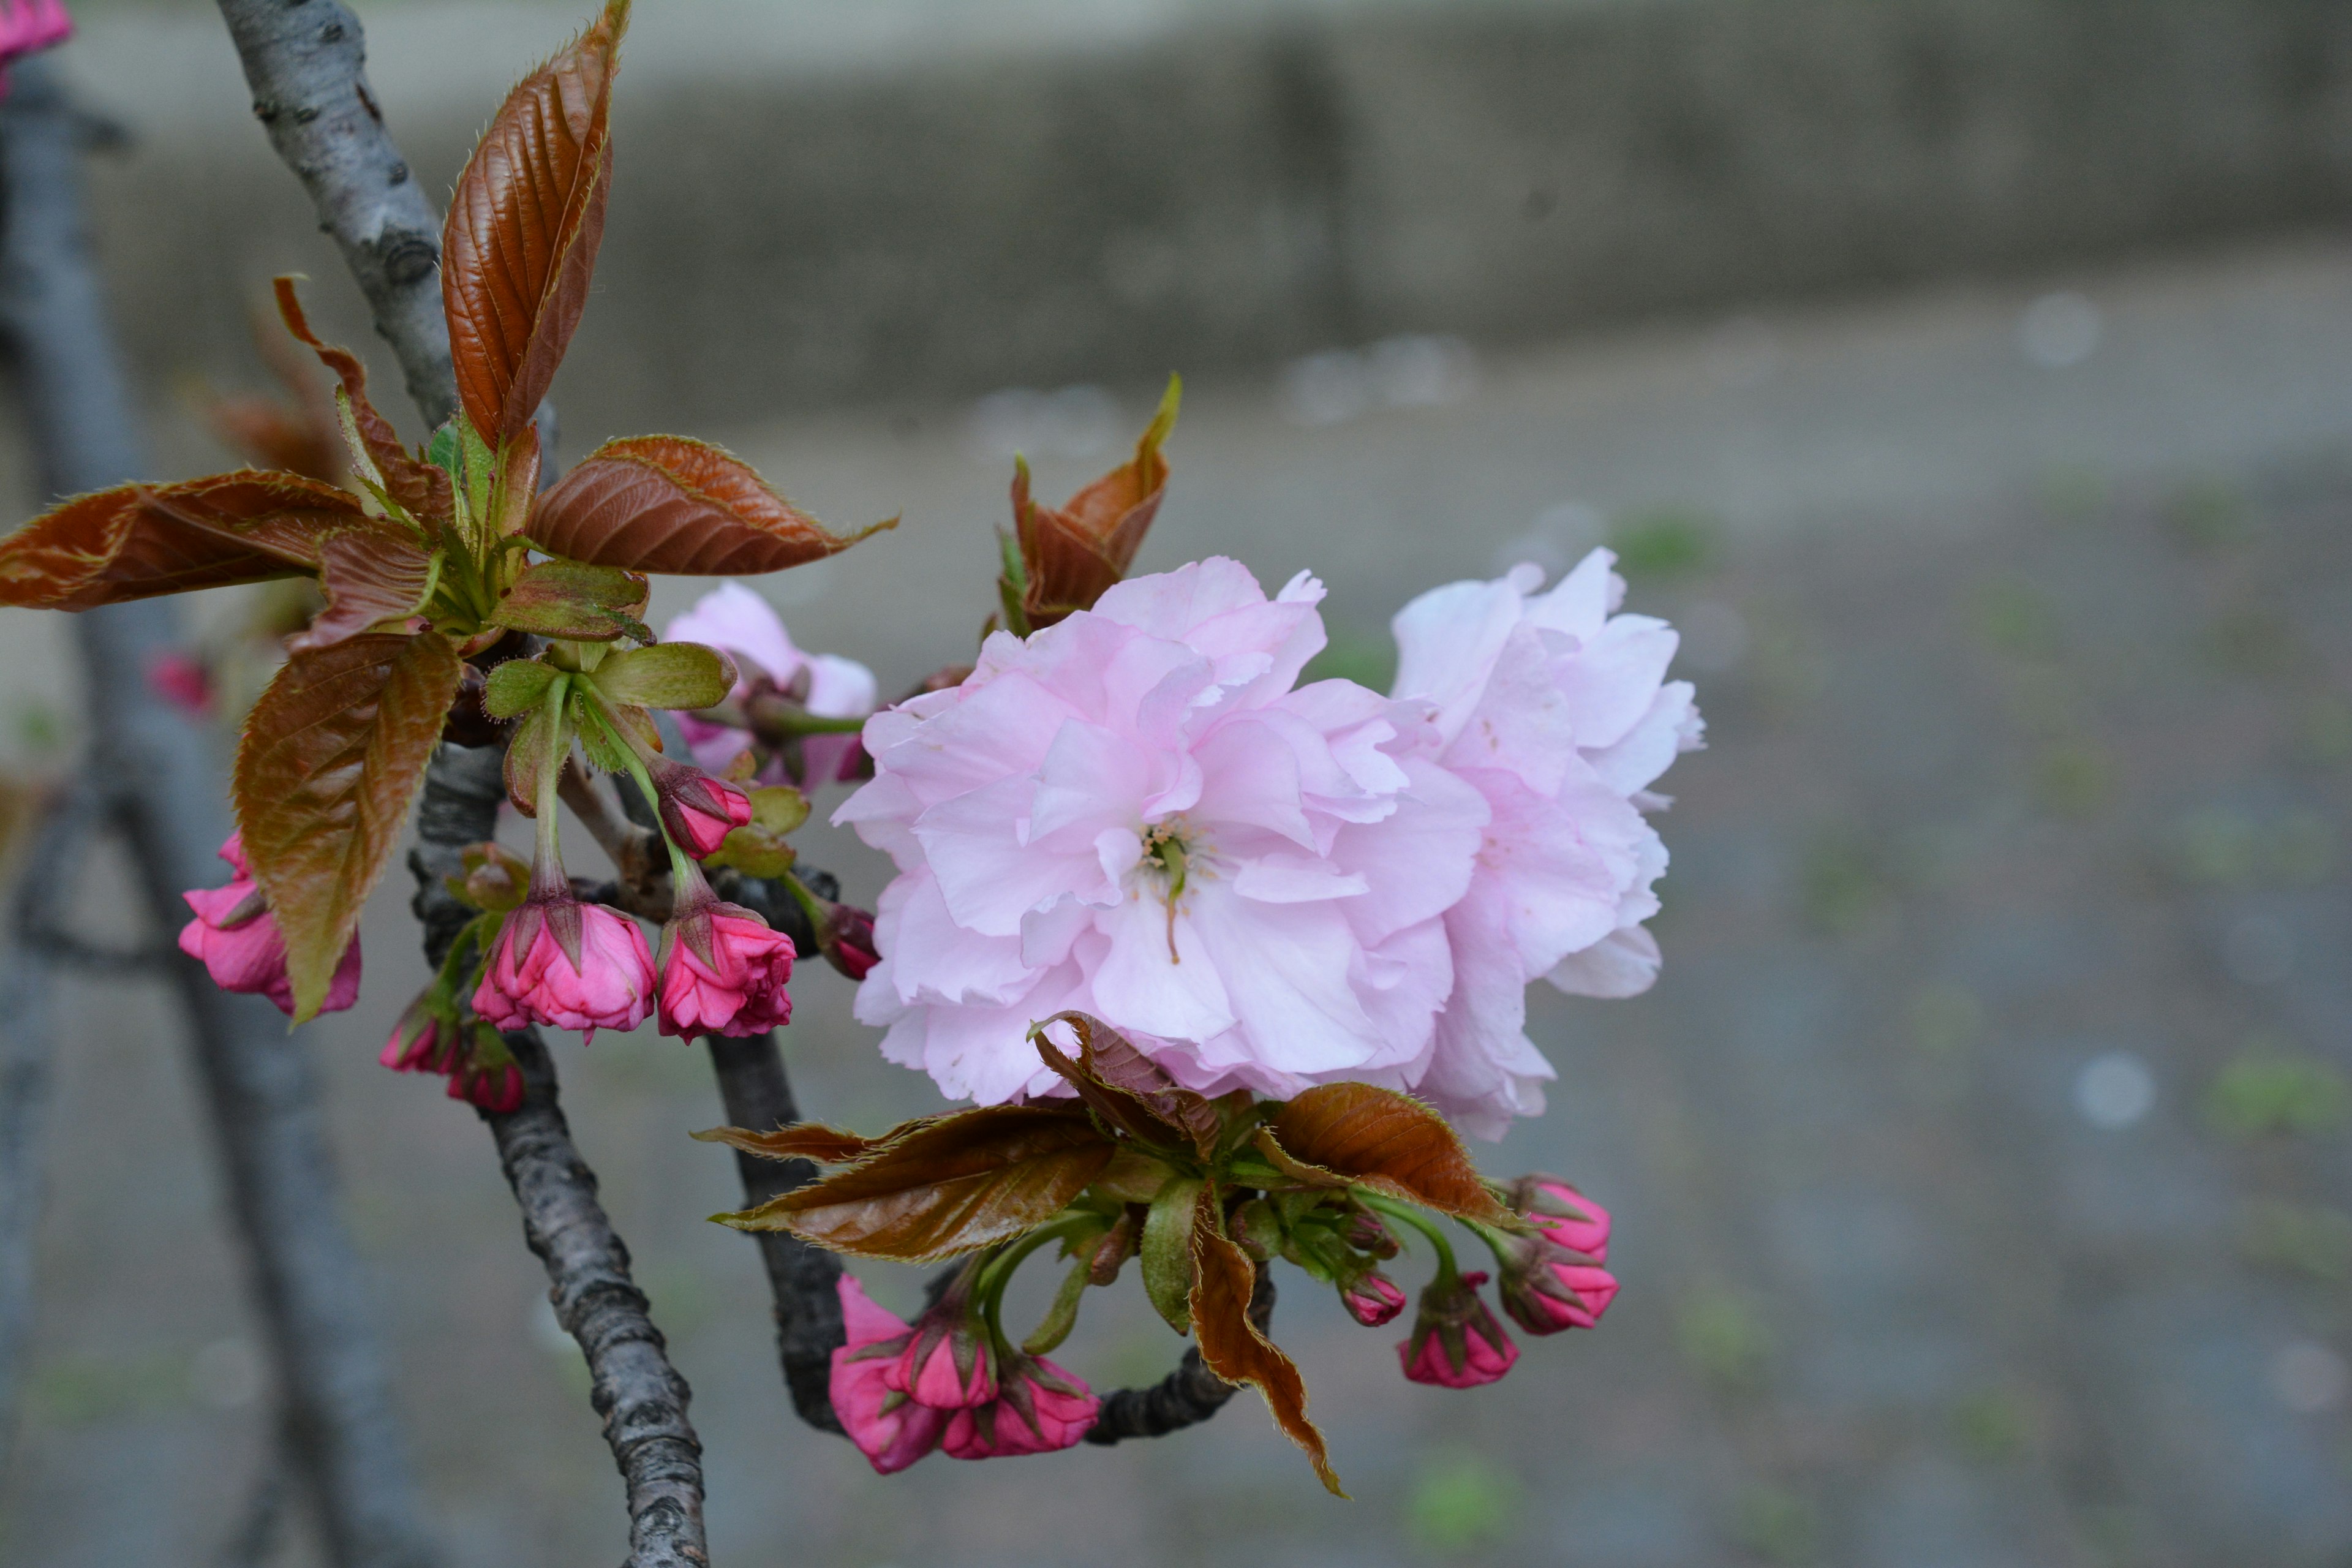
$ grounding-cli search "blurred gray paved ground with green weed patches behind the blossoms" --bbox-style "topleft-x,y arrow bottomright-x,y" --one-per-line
0,227 -> 2352,1568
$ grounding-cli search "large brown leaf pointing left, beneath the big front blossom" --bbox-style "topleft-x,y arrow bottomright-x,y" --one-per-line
713,1105 -> 1112,1262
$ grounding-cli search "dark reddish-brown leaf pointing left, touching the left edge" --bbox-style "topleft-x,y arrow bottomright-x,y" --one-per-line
0,468 -> 372,609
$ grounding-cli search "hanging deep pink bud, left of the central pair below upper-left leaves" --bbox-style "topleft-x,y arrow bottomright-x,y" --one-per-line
473,877 -> 654,1039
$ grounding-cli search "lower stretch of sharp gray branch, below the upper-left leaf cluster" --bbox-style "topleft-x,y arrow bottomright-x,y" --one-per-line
409,745 -> 710,1568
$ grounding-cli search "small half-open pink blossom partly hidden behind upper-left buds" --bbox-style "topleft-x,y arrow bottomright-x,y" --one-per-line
663,581 -> 877,785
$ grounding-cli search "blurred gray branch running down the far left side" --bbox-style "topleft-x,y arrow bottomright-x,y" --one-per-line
0,59 -> 431,1568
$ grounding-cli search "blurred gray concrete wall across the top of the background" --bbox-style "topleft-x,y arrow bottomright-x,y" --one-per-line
59,0 -> 2352,437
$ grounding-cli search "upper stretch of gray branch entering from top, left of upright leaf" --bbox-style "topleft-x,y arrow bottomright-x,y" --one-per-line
221,0 -> 454,430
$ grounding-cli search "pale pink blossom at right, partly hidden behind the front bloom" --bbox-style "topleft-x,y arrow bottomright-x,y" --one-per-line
1395,550 -> 1703,1138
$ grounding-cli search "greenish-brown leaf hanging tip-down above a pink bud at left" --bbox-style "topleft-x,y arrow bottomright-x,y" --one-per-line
235,632 -> 459,1023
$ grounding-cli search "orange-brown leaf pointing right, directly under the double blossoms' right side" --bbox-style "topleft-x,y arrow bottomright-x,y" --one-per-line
1261,1084 -> 1510,1225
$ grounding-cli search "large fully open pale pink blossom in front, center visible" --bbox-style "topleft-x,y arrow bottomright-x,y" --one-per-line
835,559 -> 1487,1102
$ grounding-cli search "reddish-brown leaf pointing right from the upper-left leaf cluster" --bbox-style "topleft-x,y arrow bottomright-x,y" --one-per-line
527,435 -> 899,576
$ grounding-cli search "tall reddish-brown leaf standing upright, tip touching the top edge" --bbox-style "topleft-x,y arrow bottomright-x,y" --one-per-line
442,0 -> 628,447
